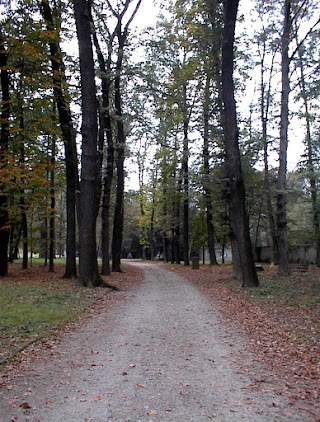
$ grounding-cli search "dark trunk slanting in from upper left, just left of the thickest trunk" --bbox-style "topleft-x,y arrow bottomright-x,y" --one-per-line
41,0 -> 79,278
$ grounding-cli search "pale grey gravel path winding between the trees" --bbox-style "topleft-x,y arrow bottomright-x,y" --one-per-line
0,263 -> 312,422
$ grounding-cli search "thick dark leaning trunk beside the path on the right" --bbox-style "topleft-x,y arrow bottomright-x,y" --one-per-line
222,0 -> 259,287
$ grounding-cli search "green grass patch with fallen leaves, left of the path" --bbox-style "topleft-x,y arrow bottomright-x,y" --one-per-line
0,263 -> 107,366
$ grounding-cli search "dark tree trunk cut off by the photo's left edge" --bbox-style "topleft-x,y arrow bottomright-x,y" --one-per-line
0,32 -> 10,277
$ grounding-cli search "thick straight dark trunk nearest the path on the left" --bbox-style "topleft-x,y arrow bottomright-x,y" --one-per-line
74,0 -> 101,287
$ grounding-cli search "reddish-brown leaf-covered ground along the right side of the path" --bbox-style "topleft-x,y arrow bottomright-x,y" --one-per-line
167,266 -> 320,408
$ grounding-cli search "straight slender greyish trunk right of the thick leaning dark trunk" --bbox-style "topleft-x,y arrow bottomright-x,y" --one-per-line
277,0 -> 291,275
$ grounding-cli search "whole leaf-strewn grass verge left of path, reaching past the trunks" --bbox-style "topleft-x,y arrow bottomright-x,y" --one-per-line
0,264 -> 143,368
